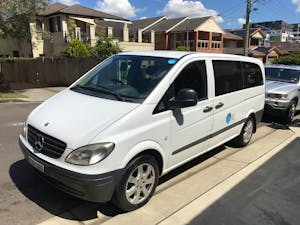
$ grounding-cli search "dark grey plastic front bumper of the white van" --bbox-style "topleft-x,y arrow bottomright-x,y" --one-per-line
19,136 -> 123,202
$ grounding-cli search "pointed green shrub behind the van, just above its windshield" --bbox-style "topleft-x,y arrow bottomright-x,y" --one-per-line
91,34 -> 122,60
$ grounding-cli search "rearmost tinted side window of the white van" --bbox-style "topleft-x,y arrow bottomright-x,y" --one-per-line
242,62 -> 264,88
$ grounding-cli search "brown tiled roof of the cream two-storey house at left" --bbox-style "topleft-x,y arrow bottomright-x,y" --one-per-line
39,3 -> 127,21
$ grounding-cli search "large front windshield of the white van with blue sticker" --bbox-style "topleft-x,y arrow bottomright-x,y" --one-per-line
71,55 -> 177,103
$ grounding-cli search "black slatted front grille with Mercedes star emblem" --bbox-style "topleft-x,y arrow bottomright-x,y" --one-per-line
27,125 -> 67,159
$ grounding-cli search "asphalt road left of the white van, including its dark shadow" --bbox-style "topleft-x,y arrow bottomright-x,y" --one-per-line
0,103 -> 300,225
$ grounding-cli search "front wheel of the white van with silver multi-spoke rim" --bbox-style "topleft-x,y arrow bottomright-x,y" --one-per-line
112,155 -> 159,212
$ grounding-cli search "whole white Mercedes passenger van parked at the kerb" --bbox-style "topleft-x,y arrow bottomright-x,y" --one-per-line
19,51 -> 265,211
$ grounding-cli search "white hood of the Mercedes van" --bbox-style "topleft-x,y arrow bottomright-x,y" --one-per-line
27,89 -> 140,149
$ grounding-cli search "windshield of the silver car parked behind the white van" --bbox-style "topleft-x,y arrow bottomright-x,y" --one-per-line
266,68 -> 300,84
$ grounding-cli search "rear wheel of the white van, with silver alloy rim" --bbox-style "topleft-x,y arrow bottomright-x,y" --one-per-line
232,116 -> 255,147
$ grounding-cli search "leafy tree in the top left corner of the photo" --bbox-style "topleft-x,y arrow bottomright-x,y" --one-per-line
0,0 -> 47,42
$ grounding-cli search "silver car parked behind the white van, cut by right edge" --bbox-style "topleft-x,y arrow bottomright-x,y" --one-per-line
265,65 -> 300,122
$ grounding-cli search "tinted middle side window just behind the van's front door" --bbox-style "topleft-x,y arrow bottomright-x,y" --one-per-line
213,61 -> 243,96
